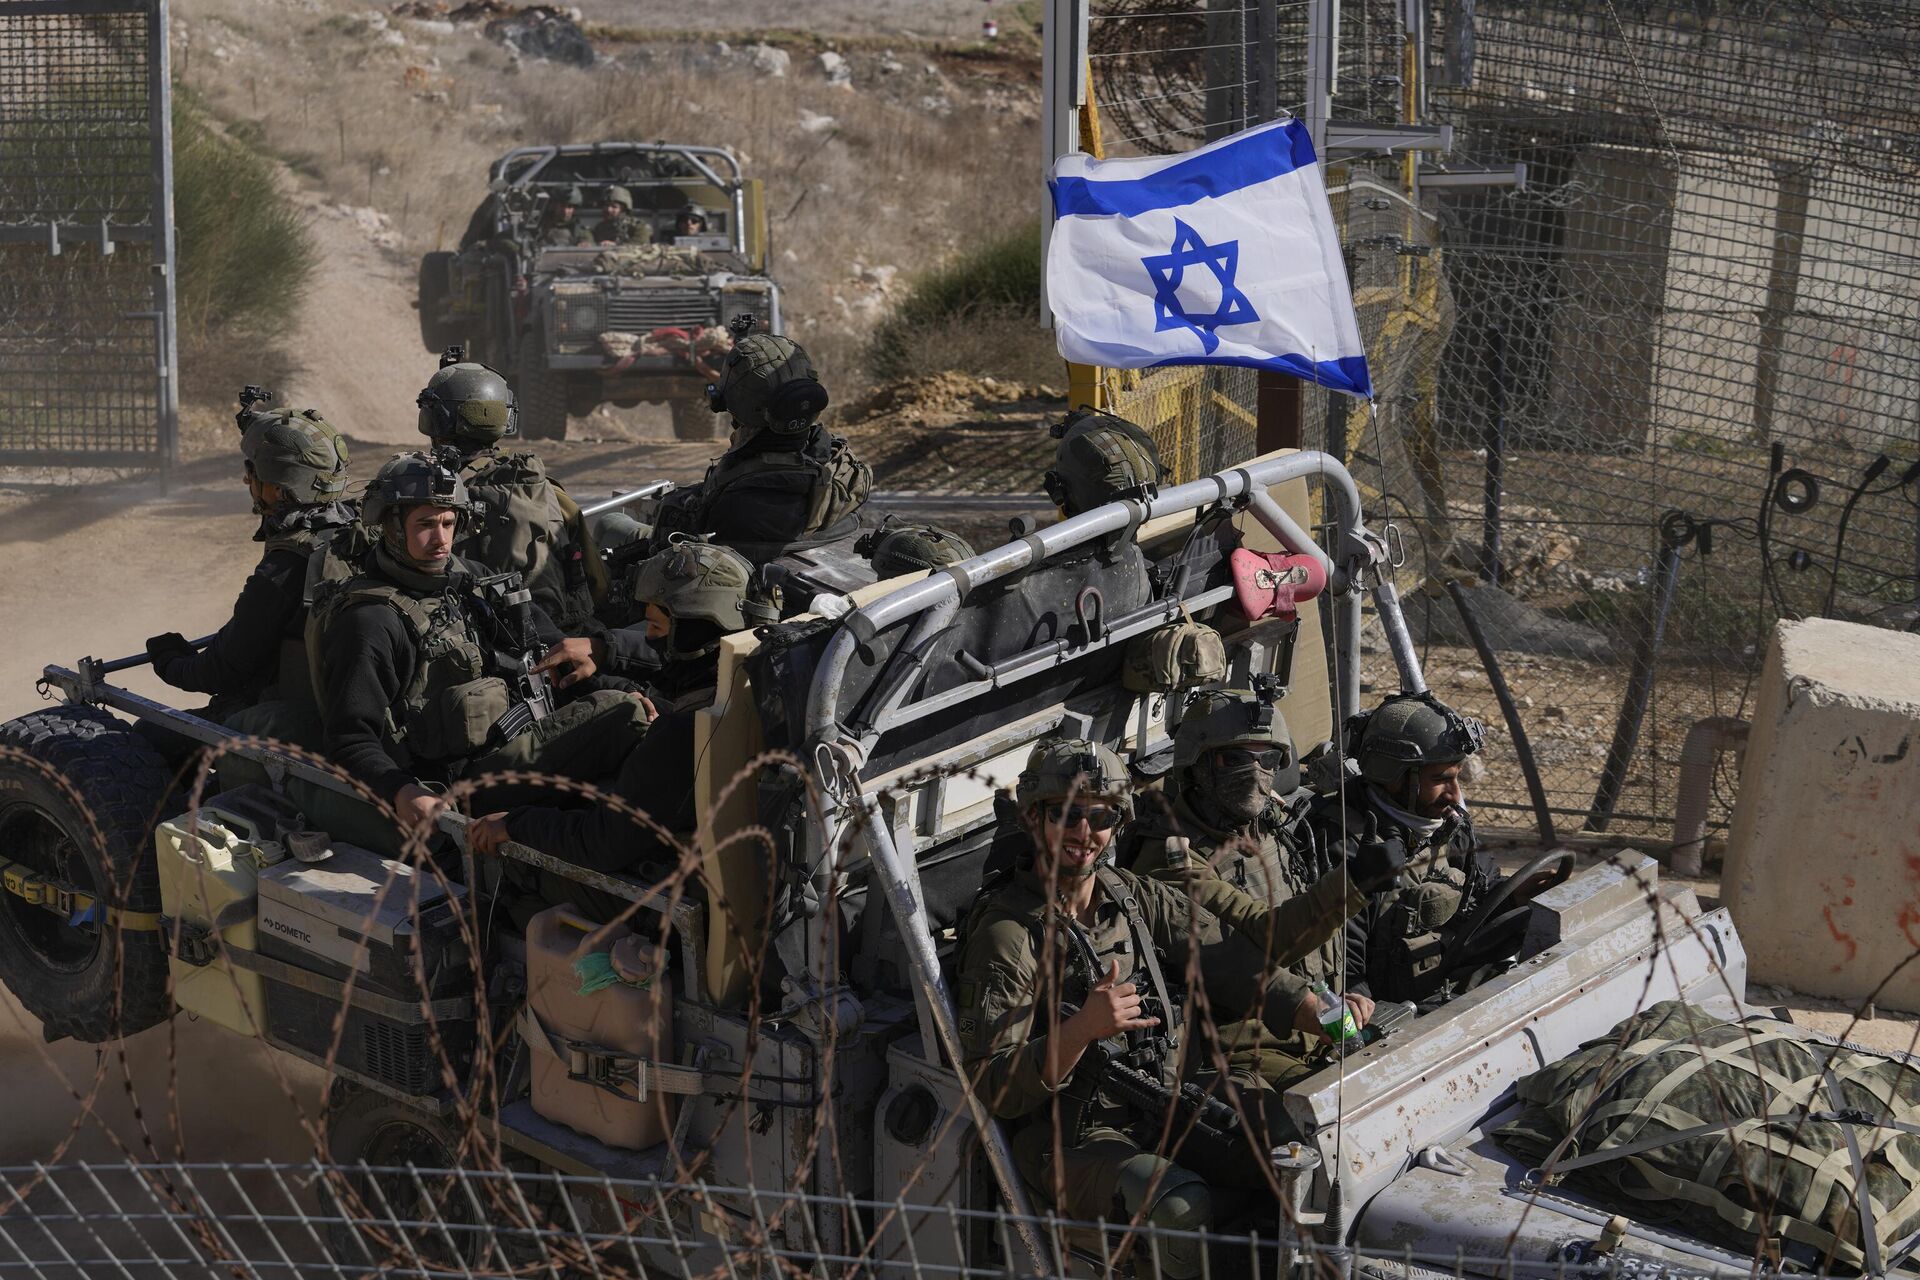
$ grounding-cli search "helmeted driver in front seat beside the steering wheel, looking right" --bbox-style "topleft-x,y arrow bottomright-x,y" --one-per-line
1309,693 -> 1492,1002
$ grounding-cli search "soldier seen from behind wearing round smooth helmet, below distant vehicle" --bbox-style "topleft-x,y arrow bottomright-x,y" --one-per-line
415,347 -> 607,633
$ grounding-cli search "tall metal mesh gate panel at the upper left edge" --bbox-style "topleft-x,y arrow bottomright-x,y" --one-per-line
0,0 -> 179,468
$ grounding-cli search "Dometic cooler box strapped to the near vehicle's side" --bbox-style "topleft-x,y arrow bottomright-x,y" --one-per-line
259,842 -> 478,1096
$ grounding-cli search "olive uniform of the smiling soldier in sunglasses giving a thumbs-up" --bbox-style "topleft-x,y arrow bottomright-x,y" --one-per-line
954,864 -> 1308,1219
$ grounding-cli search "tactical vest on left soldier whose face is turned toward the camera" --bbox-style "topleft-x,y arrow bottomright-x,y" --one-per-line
307,576 -> 513,775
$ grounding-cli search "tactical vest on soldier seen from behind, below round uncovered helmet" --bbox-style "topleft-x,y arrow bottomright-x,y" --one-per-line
457,453 -> 605,633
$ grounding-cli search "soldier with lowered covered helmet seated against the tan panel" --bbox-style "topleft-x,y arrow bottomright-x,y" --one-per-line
468,539 -> 780,919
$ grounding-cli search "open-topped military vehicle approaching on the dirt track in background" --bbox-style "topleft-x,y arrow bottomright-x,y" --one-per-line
417,142 -> 781,439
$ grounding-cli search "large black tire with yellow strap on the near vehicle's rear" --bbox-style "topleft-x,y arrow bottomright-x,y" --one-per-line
0,706 -> 173,1044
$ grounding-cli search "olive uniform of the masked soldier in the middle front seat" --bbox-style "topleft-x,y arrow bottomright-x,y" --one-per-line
1116,787 -> 1371,1090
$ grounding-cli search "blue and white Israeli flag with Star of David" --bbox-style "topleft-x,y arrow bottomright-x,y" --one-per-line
1046,119 -> 1373,397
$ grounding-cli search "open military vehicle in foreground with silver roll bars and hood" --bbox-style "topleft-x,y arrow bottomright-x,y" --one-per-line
0,453 -> 1858,1280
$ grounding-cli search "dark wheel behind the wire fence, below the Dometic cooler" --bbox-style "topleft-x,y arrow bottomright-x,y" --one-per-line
323,1079 -> 488,1270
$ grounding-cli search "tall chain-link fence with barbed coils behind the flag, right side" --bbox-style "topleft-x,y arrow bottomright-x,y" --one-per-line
1089,0 -> 1920,855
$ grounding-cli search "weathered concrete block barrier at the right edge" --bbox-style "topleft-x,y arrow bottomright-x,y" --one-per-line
1720,620 -> 1920,1011
